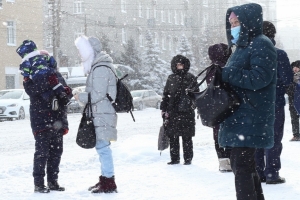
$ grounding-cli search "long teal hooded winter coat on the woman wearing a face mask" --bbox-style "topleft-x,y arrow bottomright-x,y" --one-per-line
219,3 -> 277,148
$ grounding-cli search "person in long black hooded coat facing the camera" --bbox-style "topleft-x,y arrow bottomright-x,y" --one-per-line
160,55 -> 199,165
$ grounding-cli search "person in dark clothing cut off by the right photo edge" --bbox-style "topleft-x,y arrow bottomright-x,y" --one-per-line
286,60 -> 300,141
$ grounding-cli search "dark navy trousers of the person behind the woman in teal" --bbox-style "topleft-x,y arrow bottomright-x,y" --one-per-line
255,107 -> 285,179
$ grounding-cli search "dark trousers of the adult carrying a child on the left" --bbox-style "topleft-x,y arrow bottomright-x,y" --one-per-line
33,129 -> 63,185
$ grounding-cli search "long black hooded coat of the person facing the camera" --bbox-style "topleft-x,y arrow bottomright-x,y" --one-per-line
160,55 -> 197,137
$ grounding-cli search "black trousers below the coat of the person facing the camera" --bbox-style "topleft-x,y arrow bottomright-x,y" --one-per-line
170,136 -> 194,161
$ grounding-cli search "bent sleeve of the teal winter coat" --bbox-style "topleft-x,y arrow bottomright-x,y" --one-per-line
222,41 -> 277,90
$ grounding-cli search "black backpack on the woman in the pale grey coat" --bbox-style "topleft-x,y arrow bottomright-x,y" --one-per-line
94,65 -> 135,121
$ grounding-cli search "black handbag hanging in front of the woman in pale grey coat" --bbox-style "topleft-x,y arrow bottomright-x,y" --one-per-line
76,93 -> 96,149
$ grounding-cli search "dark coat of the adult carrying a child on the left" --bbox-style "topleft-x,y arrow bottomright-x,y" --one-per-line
23,72 -> 71,133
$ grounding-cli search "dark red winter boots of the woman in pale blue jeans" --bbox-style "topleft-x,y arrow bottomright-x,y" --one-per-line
92,176 -> 117,193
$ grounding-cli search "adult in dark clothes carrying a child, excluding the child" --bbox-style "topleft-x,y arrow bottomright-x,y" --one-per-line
18,41 -> 72,193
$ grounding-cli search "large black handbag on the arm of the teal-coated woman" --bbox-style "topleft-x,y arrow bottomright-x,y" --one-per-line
187,65 -> 240,127
